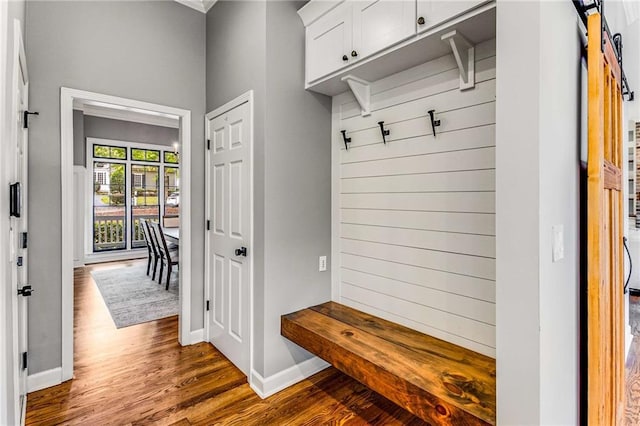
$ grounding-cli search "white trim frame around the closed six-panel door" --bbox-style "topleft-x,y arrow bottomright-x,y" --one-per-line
204,90 -> 254,383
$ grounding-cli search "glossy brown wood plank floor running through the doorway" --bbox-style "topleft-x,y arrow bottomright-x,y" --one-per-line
26,262 -> 425,426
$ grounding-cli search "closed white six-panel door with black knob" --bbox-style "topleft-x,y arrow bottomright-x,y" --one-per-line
207,97 -> 252,375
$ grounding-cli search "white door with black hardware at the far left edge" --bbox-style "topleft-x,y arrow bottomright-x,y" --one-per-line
9,28 -> 31,423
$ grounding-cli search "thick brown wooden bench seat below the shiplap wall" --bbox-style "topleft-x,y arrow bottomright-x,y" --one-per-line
281,302 -> 496,426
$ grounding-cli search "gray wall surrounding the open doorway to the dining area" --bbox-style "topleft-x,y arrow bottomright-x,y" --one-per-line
26,1 -> 205,374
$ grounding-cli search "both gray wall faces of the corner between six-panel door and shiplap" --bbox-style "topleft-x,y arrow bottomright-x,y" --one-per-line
207,1 -> 331,377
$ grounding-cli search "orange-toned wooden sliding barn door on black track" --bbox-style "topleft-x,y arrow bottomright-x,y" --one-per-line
587,13 -> 624,426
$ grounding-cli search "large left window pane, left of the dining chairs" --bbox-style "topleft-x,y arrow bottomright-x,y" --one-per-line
93,161 -> 127,252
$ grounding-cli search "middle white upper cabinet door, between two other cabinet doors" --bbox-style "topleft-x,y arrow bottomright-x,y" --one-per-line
349,0 -> 416,60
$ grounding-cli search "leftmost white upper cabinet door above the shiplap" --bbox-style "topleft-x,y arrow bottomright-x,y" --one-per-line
306,3 -> 352,83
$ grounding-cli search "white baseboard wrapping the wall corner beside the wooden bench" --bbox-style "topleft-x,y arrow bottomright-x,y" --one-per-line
249,357 -> 331,399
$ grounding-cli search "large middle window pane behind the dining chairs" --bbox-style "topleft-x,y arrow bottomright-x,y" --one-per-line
131,164 -> 160,248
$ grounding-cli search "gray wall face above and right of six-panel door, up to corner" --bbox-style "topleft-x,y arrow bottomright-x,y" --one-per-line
206,0 -> 267,371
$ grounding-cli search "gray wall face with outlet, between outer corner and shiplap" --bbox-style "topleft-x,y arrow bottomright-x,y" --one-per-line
256,1 -> 331,377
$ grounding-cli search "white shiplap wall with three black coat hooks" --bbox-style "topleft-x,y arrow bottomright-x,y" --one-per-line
332,40 -> 496,357
